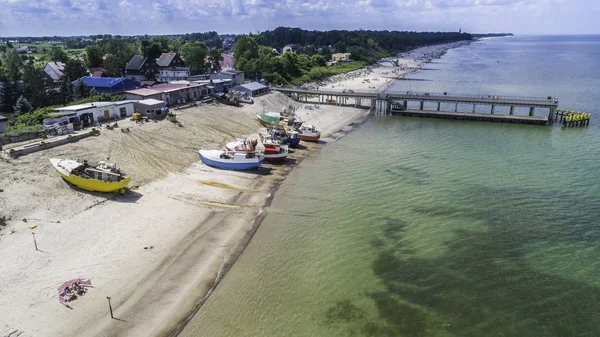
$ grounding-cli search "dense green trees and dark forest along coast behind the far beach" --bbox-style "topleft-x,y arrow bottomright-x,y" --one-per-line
233,27 -> 472,84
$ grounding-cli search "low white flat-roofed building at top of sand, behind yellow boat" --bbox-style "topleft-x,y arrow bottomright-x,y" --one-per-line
49,101 -> 135,127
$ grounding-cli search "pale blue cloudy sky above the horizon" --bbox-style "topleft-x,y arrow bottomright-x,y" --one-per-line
0,0 -> 600,36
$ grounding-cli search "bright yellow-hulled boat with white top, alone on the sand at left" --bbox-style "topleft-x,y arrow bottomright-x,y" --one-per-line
50,158 -> 131,193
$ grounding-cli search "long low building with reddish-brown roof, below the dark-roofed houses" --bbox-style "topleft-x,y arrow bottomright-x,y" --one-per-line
123,80 -> 210,106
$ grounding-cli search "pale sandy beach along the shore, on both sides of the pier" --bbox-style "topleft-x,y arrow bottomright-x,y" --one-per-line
0,40 -> 468,337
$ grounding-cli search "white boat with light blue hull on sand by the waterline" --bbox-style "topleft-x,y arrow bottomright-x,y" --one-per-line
198,150 -> 264,170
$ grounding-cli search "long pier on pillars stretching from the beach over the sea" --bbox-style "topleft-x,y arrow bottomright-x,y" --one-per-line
272,87 -> 558,125
